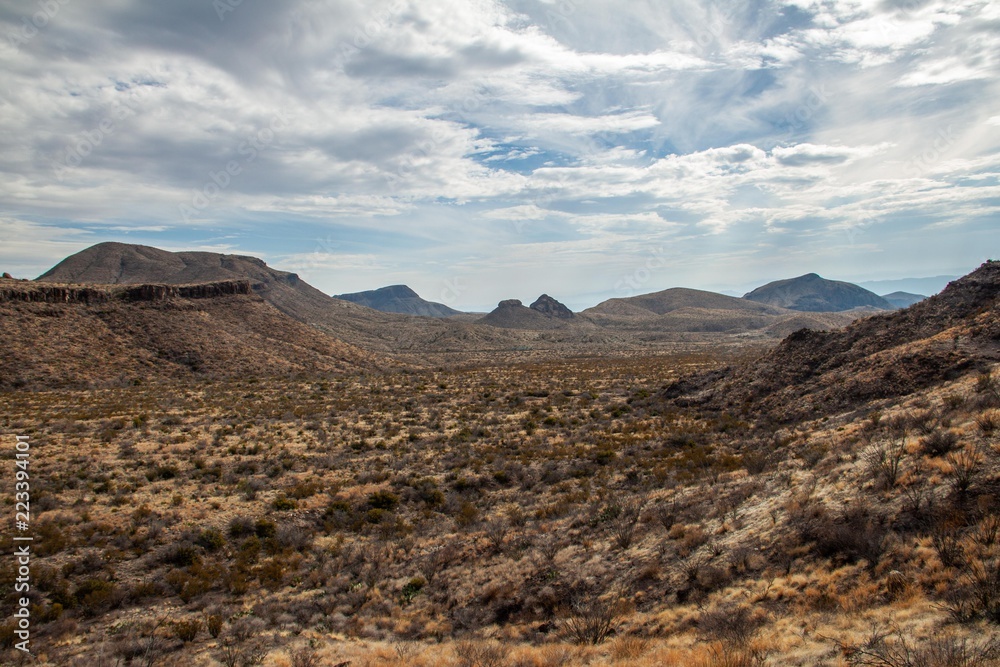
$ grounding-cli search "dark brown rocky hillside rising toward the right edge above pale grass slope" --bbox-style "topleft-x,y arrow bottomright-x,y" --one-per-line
664,261 -> 1000,421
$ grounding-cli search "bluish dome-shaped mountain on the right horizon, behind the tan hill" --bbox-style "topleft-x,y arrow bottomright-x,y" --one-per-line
743,273 -> 893,313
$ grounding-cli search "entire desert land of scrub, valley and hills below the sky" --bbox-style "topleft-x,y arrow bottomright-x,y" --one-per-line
0,243 -> 1000,667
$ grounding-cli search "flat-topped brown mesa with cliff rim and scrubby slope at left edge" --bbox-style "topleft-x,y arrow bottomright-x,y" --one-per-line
0,279 -> 386,390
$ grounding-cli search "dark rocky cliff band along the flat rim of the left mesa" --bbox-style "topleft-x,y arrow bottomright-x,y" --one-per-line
0,280 -> 253,304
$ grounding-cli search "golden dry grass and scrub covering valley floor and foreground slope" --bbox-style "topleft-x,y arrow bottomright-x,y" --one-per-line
0,356 -> 1000,667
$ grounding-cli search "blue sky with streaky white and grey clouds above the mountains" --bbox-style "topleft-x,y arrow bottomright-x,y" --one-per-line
0,0 -> 1000,310
